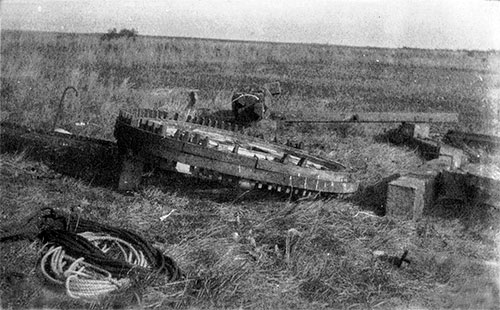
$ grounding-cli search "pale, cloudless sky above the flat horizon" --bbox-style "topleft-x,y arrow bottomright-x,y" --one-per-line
0,0 -> 500,50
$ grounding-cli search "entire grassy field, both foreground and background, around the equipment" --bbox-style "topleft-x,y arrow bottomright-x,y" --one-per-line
0,31 -> 500,309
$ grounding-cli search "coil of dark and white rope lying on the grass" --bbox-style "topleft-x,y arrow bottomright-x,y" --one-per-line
1,208 -> 183,301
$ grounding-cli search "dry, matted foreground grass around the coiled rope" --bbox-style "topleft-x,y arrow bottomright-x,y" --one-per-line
0,154 -> 500,309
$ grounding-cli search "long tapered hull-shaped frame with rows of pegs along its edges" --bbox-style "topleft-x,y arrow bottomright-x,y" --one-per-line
114,109 -> 358,196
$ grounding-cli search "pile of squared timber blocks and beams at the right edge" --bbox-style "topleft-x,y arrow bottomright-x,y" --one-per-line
386,124 -> 500,220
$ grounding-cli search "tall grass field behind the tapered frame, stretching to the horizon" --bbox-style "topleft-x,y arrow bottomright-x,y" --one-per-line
1,31 -> 500,138
